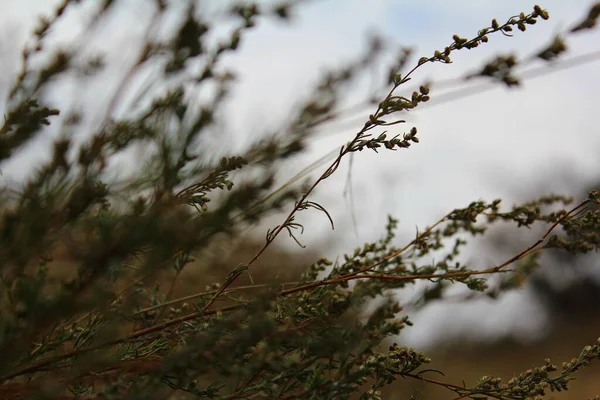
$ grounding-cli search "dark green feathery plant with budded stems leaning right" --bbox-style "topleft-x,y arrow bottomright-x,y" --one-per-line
0,0 -> 600,400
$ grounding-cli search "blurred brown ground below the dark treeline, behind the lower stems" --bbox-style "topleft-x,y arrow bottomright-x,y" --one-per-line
383,315 -> 600,400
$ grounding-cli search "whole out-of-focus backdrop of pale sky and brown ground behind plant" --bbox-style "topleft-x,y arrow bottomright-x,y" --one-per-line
0,0 -> 600,398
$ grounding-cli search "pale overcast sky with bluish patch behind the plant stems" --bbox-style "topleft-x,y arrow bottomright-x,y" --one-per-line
0,0 -> 600,345
